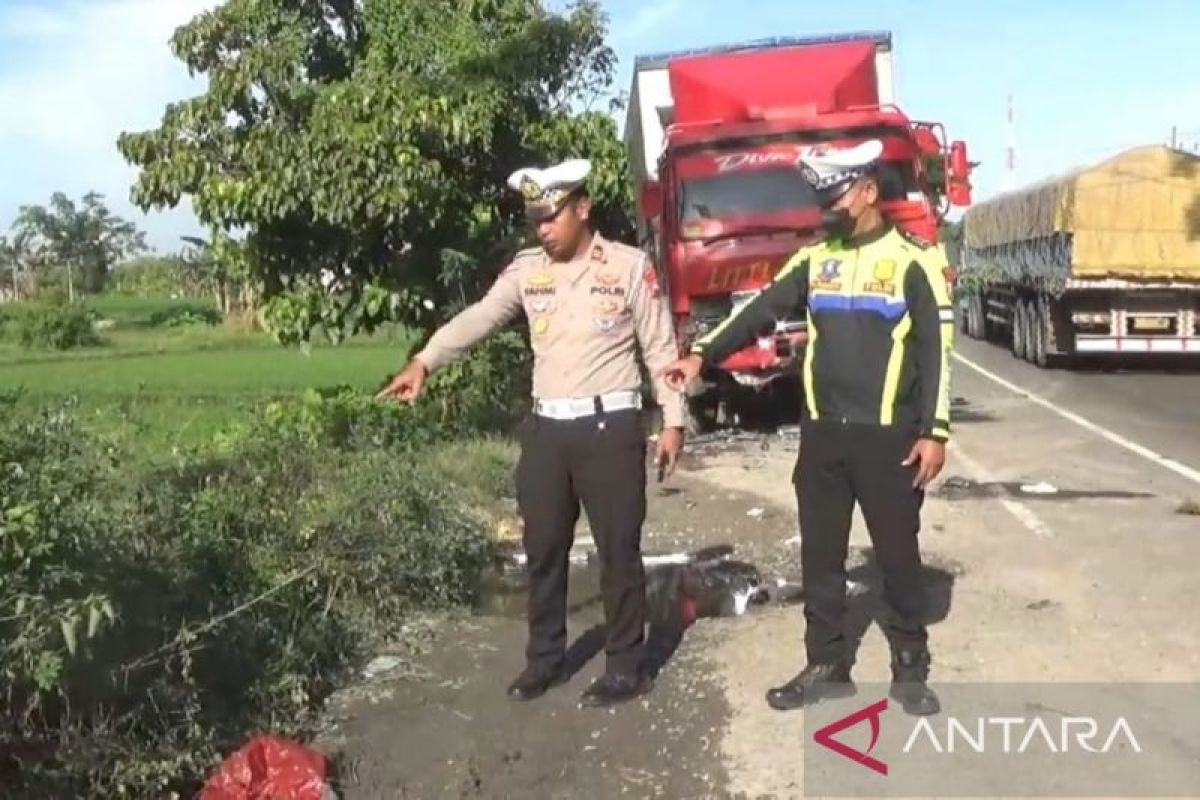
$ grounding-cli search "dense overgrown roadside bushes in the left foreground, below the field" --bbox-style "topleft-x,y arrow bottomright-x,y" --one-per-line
0,395 -> 497,798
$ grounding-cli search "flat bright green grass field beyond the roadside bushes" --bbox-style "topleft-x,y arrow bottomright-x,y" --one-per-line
0,297 -> 422,455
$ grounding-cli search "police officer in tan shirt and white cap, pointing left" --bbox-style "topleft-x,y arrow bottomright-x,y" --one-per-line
380,160 -> 683,706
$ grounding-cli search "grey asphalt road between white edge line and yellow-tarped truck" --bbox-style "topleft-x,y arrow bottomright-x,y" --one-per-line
952,335 -> 1200,479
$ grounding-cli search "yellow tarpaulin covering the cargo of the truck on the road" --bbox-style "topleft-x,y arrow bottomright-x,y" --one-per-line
964,146 -> 1200,279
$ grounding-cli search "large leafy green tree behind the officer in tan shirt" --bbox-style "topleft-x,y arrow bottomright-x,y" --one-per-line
119,0 -> 632,343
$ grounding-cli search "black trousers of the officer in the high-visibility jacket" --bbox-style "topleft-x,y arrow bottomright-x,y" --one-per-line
793,421 -> 928,663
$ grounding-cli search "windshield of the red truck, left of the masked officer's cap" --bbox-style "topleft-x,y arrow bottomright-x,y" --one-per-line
679,167 -> 817,222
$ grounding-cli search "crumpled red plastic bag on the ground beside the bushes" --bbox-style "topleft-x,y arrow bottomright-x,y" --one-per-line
200,736 -> 335,800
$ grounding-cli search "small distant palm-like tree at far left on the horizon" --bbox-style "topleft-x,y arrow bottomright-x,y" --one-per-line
13,192 -> 146,301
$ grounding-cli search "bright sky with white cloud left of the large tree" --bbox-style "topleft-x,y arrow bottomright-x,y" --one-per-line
0,0 -> 217,249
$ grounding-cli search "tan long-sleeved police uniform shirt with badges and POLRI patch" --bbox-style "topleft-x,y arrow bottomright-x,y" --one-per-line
416,234 -> 683,427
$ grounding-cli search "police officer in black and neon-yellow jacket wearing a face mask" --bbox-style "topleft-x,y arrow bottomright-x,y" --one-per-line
667,140 -> 954,714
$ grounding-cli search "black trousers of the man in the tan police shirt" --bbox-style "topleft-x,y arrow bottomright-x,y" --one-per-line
517,409 -> 646,674
